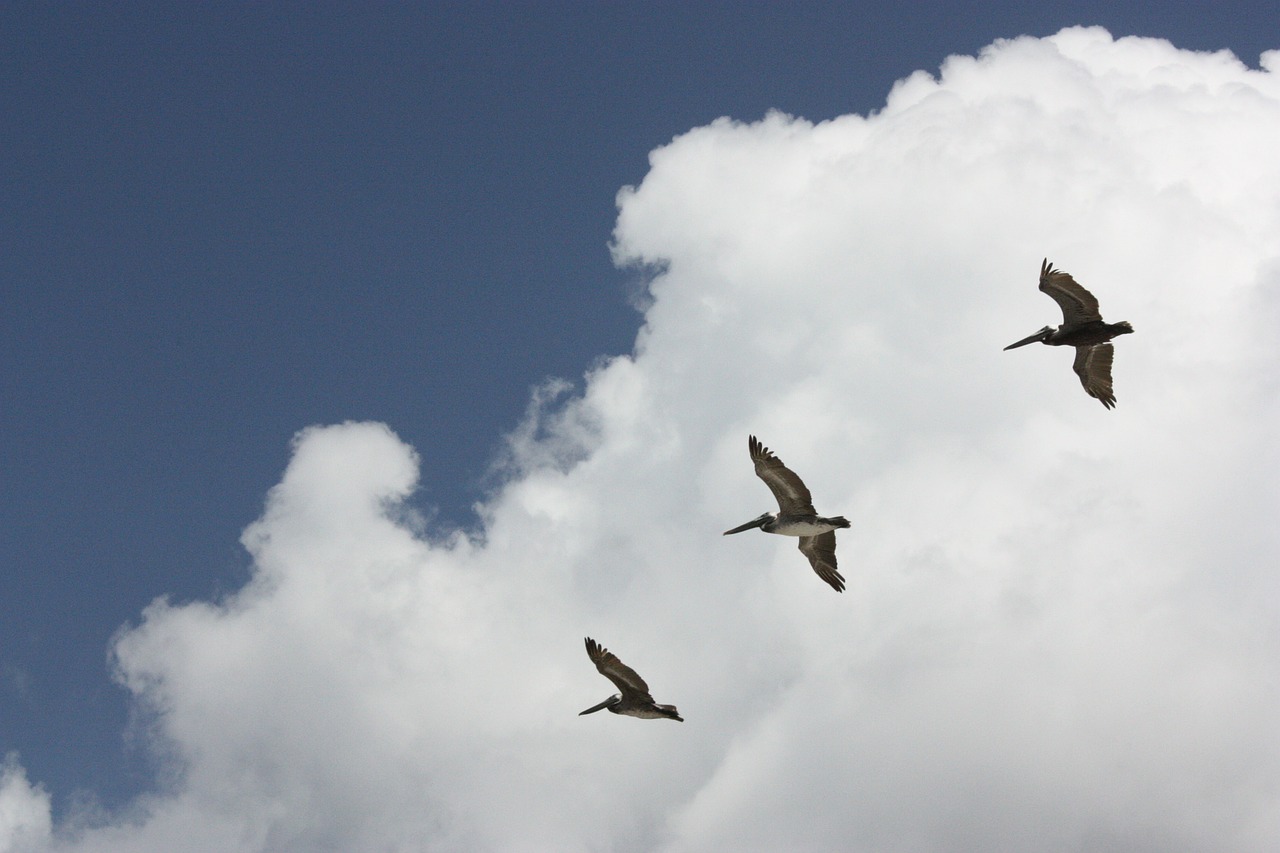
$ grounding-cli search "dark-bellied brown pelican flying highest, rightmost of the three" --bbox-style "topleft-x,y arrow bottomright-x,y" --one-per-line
1005,257 -> 1133,409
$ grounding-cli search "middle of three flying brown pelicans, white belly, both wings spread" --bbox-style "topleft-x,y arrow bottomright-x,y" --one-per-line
724,435 -> 849,592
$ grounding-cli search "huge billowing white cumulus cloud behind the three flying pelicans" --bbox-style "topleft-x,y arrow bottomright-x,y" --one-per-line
12,28 -> 1280,853
